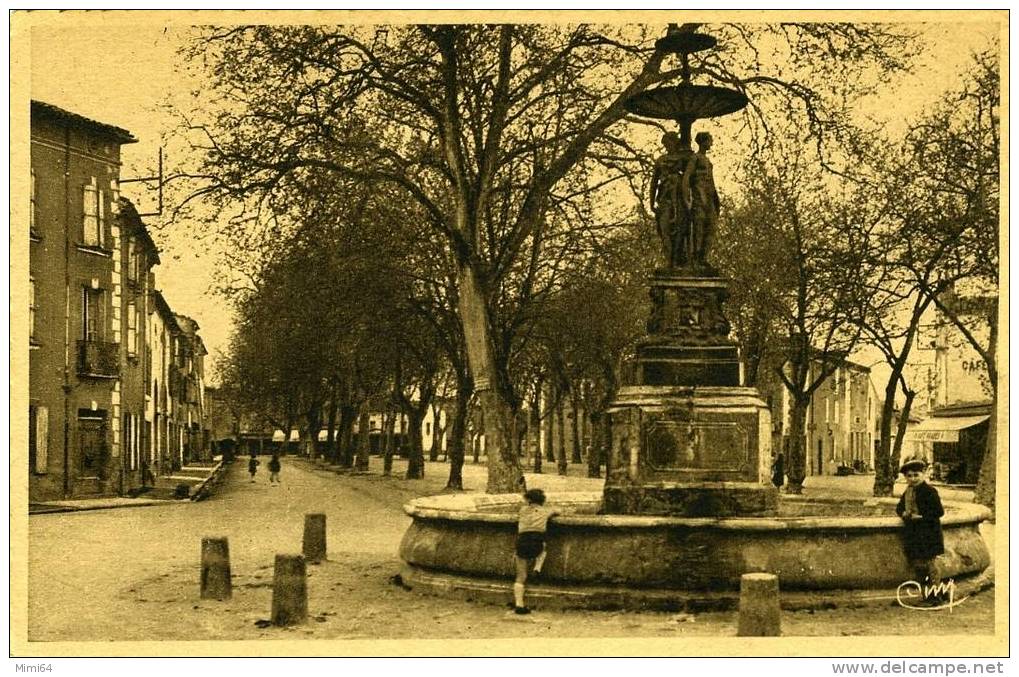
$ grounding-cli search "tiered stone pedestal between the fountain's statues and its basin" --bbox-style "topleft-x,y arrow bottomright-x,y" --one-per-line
603,270 -> 779,517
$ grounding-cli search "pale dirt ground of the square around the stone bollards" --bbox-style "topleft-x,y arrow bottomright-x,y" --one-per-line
29,459 -> 995,641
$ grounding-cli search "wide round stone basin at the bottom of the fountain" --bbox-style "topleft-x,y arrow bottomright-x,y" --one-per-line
399,491 -> 991,611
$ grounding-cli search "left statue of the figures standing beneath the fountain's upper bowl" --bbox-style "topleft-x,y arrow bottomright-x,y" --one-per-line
651,132 -> 694,268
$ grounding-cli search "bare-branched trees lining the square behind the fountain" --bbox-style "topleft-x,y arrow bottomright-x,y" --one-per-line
171,23 -> 997,505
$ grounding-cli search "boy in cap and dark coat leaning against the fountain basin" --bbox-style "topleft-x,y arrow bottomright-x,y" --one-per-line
896,457 -> 945,603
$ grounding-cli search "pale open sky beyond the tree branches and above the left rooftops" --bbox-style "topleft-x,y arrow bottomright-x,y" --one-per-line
23,11 -> 996,385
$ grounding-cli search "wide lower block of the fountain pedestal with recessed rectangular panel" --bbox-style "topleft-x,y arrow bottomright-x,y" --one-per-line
604,385 -> 777,517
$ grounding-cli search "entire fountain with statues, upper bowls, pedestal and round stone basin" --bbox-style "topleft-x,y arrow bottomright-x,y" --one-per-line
399,26 -> 989,611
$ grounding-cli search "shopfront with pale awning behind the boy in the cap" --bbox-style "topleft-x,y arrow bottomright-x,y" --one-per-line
903,404 -> 990,484
